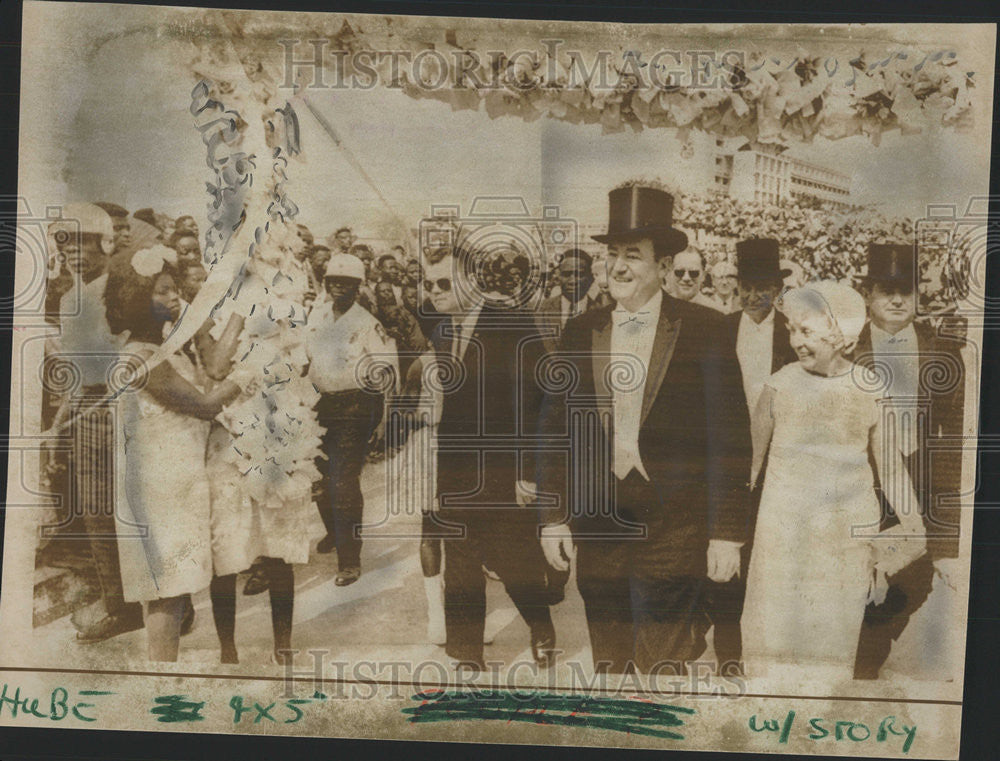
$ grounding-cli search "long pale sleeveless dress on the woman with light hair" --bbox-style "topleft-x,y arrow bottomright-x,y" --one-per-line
741,362 -> 879,679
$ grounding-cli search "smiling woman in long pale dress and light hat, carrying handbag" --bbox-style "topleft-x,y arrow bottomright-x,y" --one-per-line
741,282 -> 924,681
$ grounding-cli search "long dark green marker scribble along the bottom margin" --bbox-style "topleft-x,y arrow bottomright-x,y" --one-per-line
402,690 -> 695,740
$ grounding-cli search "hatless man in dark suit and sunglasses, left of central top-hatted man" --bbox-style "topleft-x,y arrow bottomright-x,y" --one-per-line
424,245 -> 555,670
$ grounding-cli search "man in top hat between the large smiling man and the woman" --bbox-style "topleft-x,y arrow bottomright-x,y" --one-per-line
708,238 -> 797,673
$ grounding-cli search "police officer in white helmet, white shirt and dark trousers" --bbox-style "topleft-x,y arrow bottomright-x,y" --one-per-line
306,253 -> 399,586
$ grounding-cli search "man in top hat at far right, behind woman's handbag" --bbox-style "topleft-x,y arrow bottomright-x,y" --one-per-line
854,244 -> 965,679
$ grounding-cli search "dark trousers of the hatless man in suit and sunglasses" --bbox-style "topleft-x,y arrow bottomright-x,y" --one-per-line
442,508 -> 552,665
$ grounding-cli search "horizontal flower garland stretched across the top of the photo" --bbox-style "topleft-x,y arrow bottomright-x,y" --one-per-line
244,15 -> 975,144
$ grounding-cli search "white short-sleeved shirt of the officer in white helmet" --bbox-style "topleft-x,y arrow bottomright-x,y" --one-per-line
306,301 -> 399,394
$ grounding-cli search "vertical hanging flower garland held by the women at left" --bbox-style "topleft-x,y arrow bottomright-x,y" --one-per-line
186,20 -> 324,509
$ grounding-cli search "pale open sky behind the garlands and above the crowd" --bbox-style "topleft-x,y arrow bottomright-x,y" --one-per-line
22,22 -> 989,248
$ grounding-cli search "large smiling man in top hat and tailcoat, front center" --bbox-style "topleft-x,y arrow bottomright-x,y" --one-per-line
538,185 -> 750,673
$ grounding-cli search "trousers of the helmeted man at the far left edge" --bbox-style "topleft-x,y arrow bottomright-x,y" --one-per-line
71,394 -> 142,617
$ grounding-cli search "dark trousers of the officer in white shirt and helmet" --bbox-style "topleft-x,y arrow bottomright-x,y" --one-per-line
314,390 -> 382,570
